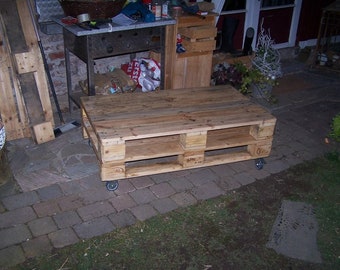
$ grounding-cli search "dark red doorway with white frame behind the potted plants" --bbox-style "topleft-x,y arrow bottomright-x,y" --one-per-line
213,0 -> 302,49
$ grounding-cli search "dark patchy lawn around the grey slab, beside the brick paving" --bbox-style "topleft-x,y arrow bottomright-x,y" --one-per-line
13,152 -> 340,270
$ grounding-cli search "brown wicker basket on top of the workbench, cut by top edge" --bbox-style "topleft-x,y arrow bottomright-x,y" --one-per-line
59,0 -> 126,20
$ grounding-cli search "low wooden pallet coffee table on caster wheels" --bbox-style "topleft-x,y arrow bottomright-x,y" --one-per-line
81,85 -> 276,190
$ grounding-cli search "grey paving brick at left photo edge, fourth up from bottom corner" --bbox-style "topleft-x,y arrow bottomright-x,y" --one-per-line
2,191 -> 39,210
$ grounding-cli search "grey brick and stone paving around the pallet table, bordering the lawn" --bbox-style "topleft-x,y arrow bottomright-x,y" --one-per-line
0,60 -> 340,268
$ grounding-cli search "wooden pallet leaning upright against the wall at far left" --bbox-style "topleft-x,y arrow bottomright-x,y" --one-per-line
0,0 -> 54,143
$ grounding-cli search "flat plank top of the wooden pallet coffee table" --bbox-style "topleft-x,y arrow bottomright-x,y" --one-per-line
81,85 -> 275,142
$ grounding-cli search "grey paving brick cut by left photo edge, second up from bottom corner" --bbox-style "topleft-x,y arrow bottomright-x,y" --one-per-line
0,224 -> 32,249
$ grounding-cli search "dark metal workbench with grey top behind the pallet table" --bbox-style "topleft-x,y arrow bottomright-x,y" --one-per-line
55,19 -> 176,109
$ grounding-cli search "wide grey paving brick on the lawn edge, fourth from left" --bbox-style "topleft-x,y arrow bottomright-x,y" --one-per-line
73,217 -> 115,239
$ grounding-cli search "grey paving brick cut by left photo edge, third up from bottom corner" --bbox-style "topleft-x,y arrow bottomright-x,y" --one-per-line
0,207 -> 37,228
